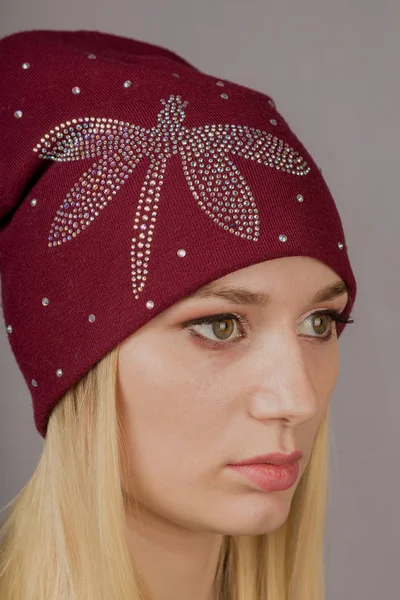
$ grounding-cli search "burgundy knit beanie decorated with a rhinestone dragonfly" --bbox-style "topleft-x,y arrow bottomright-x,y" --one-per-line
0,31 -> 356,437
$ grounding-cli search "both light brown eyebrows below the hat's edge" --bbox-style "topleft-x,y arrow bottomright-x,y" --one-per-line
187,280 -> 350,307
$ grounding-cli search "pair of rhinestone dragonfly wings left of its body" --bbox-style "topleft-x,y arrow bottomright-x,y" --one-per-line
34,117 -> 152,247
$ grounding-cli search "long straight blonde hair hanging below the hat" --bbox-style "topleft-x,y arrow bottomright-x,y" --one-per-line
0,347 -> 328,600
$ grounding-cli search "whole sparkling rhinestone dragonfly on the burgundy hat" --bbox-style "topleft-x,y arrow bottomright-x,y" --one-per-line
33,95 -> 310,299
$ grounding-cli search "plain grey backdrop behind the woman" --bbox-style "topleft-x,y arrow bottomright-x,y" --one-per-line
0,0 -> 400,600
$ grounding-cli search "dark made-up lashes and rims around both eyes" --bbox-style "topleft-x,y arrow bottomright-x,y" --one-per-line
183,308 -> 354,349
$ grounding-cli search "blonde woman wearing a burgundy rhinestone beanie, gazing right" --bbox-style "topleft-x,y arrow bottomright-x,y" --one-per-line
0,31 -> 356,600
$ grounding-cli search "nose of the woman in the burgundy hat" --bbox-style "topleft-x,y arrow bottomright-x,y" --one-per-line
247,331 -> 321,426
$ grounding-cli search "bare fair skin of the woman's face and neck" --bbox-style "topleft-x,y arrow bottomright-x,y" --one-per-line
118,257 -> 348,600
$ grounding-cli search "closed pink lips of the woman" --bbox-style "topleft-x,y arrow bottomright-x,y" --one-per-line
227,451 -> 303,491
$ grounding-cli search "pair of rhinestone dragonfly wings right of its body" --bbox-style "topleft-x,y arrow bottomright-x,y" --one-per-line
181,124 -> 310,241
